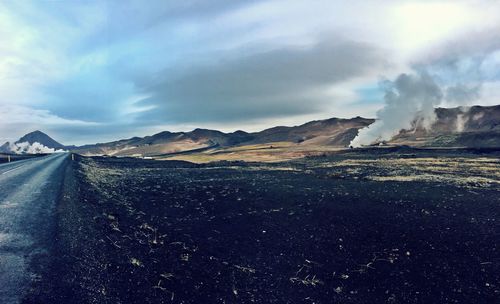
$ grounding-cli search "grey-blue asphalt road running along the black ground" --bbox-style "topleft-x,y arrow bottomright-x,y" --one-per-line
0,153 -> 68,304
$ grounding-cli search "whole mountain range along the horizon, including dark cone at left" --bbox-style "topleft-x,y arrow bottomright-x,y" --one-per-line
0,105 -> 500,157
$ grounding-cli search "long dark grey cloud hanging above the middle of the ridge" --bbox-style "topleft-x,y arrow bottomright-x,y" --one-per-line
133,39 -> 386,123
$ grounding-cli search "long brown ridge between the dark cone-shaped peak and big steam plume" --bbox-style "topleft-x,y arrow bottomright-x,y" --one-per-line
72,117 -> 374,156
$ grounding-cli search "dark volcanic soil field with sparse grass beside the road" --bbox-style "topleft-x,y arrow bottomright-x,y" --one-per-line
27,151 -> 500,304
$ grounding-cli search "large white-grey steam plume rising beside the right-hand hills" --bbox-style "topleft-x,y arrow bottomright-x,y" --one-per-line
351,73 -> 443,147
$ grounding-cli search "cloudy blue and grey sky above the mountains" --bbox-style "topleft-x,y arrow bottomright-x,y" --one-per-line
0,0 -> 500,144
